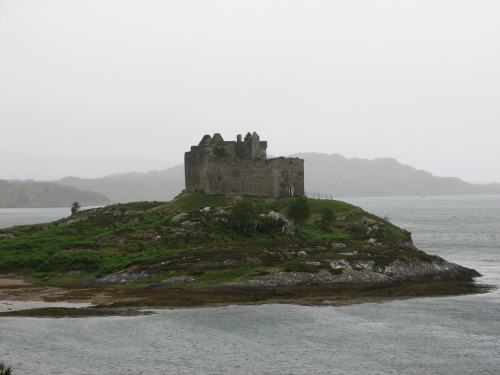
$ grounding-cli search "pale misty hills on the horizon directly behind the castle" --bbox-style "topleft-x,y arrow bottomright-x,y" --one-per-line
50,153 -> 500,202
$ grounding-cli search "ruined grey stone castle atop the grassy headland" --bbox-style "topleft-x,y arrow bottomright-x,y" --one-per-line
184,132 -> 304,198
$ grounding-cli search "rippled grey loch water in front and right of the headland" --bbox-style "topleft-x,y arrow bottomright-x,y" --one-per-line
0,196 -> 500,375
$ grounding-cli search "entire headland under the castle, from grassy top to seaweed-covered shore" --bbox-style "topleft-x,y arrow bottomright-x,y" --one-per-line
0,192 -> 485,316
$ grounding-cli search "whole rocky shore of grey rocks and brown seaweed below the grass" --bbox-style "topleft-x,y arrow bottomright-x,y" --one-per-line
0,260 -> 490,318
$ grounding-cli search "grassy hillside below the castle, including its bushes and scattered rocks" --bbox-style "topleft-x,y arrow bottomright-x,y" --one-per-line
0,193 -> 430,286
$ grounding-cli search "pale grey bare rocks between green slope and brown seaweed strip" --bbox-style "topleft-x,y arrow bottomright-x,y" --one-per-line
73,257 -> 481,289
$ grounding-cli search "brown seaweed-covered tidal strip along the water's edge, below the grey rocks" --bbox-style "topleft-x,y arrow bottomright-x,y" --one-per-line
0,279 -> 494,318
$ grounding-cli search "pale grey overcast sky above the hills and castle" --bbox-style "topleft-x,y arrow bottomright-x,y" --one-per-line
0,0 -> 500,182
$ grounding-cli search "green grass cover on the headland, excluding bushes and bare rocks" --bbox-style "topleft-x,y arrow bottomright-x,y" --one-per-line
0,192 -> 424,285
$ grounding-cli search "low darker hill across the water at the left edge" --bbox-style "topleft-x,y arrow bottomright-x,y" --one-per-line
0,180 -> 111,207
